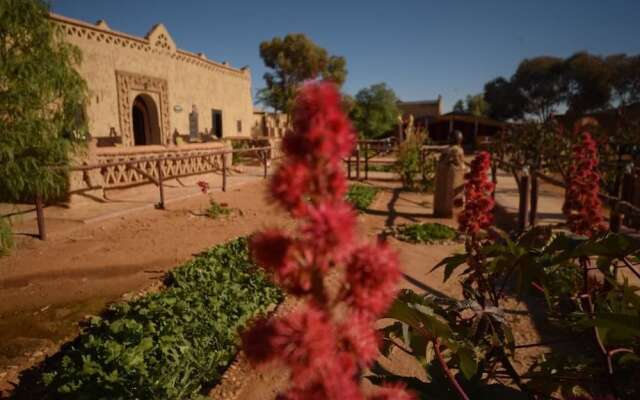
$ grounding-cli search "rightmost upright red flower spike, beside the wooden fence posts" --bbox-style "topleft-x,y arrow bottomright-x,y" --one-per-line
562,132 -> 607,237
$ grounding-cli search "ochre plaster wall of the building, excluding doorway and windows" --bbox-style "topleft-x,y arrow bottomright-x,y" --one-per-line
51,15 -> 253,146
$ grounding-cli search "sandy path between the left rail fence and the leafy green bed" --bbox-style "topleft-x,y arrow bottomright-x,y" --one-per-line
0,180 -> 287,396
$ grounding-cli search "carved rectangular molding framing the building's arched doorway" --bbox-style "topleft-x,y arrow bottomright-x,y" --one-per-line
116,71 -> 171,146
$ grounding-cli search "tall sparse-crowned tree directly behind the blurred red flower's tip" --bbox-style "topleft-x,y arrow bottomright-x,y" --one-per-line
257,33 -> 347,114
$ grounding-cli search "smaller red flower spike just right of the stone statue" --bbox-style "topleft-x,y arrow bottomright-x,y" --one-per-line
458,151 -> 495,237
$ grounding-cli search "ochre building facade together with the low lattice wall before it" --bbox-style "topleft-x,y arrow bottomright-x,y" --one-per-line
50,14 -> 286,202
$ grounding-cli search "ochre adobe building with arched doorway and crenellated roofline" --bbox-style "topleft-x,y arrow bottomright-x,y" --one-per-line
50,14 -> 253,148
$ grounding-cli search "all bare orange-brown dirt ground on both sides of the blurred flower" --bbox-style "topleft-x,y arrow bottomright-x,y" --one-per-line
0,173 -> 552,399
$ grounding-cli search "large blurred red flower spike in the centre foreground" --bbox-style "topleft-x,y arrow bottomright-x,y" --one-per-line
243,82 -> 411,400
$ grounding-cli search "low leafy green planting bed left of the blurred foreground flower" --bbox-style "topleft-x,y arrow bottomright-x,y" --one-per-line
42,239 -> 282,399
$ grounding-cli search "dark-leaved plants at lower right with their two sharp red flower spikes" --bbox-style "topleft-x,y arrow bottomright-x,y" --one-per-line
383,145 -> 640,399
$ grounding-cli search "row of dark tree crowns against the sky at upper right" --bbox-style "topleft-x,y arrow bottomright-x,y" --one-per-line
484,51 -> 640,122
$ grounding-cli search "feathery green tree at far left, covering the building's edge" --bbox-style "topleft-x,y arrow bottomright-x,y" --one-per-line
0,0 -> 86,202
